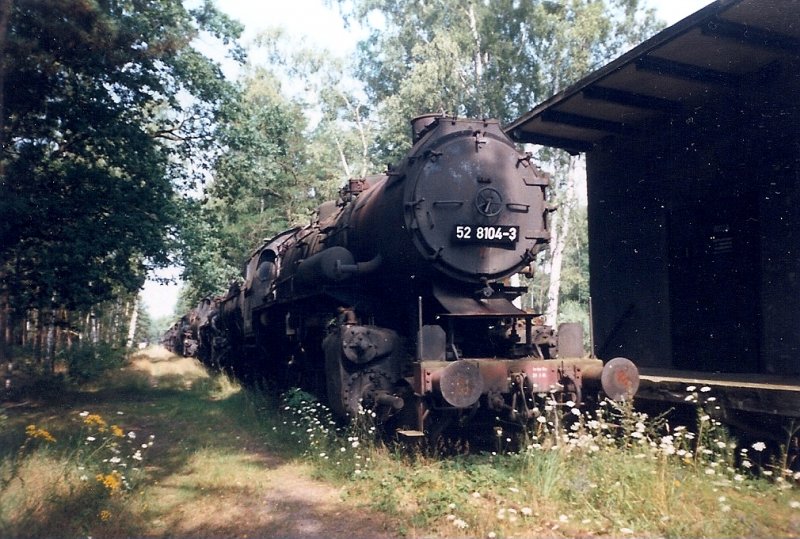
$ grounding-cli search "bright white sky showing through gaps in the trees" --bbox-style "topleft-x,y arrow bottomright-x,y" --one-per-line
142,0 -> 711,318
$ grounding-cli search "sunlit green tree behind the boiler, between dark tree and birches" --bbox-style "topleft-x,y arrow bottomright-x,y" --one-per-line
181,29 -> 371,306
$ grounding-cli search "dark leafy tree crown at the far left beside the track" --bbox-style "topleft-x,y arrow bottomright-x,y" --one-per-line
0,0 -> 241,362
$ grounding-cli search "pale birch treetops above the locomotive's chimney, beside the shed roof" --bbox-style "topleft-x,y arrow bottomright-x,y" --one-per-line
339,0 -> 660,165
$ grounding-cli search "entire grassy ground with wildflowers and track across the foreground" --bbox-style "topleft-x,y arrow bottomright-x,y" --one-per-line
0,352 -> 800,538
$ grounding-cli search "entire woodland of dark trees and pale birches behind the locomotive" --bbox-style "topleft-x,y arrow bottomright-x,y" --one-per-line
0,0 -> 700,372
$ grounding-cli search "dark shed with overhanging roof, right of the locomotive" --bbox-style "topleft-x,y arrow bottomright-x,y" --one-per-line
506,0 -> 800,375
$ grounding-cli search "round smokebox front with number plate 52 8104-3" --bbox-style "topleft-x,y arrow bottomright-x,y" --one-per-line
402,119 -> 549,282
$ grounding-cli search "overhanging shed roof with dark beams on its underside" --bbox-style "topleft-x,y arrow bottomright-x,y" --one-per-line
505,0 -> 800,153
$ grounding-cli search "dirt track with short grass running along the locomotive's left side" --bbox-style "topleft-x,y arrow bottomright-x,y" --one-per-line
0,347 -> 400,539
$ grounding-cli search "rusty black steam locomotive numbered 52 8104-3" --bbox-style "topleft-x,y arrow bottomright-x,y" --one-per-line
171,115 -> 639,435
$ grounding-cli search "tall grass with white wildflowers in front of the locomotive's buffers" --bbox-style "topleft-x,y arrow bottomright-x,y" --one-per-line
283,388 -> 800,537
